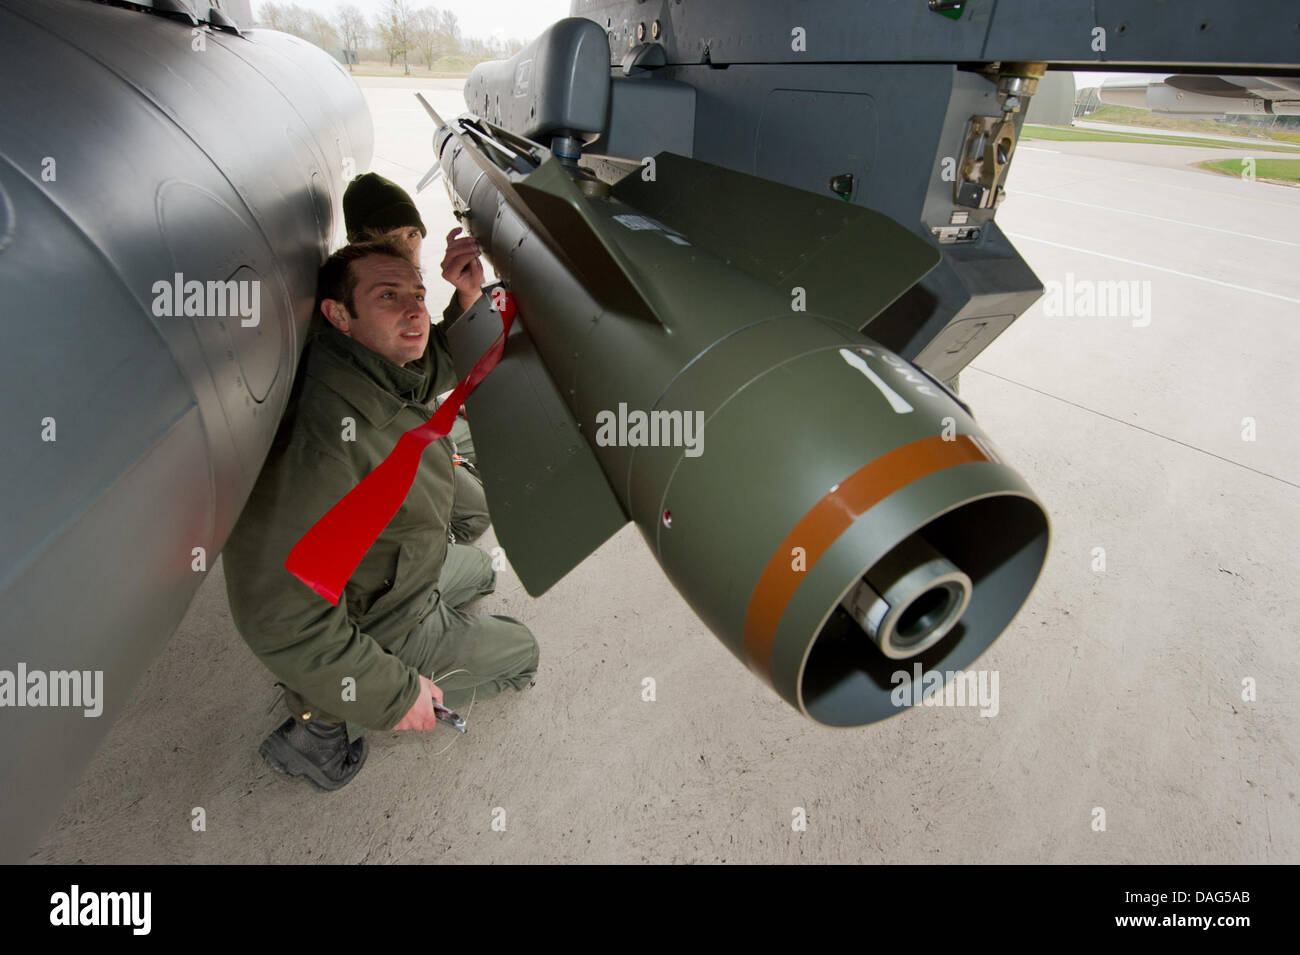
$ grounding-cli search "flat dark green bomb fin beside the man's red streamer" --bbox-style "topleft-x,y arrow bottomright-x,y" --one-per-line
447,291 -> 628,596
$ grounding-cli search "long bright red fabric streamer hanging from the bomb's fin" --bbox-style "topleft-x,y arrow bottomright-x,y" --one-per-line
285,288 -> 516,607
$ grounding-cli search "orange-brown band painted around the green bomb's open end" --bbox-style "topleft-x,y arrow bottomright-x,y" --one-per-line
745,434 -> 998,682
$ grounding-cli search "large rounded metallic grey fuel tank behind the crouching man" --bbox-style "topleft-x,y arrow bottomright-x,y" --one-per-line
0,0 -> 373,861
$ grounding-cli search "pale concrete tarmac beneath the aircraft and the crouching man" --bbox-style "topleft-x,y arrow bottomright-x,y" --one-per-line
33,81 -> 1300,864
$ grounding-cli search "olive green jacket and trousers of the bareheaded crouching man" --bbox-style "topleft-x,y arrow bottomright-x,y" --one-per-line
222,326 -> 538,735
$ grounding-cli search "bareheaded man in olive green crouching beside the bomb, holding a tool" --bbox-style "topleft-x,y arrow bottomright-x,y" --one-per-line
222,235 -> 538,789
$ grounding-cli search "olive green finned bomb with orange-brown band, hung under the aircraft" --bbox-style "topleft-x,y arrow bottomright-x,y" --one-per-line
425,104 -> 1049,726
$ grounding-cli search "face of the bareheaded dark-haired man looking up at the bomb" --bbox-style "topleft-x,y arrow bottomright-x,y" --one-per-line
321,254 -> 429,365
